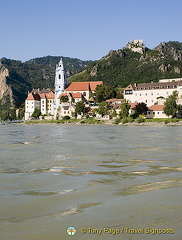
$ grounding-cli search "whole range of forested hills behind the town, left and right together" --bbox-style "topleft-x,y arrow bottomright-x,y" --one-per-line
0,41 -> 182,110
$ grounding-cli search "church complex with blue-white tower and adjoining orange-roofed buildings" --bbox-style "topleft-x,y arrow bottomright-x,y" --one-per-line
25,58 -> 103,120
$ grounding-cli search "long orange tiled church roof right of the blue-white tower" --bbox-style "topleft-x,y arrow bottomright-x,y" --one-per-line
65,81 -> 103,92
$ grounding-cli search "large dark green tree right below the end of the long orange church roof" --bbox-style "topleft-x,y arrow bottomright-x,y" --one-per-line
93,85 -> 115,102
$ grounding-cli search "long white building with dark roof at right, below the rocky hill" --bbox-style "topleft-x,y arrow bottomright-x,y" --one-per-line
124,78 -> 182,107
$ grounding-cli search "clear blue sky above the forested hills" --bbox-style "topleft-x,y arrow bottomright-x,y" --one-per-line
0,0 -> 182,62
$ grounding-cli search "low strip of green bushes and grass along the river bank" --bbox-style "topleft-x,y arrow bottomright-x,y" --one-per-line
24,117 -> 182,126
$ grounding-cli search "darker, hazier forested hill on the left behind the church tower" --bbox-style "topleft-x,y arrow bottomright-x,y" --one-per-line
0,56 -> 91,109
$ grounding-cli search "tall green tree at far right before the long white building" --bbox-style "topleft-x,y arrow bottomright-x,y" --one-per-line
164,91 -> 178,117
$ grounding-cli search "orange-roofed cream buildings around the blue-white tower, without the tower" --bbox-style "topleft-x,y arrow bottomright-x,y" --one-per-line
25,81 -> 103,120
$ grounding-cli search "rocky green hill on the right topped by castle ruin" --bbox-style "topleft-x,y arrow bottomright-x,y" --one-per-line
69,41 -> 182,87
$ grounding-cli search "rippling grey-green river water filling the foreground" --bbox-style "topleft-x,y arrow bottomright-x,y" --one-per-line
0,124 -> 182,240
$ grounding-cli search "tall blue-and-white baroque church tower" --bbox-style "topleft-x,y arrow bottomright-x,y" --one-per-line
54,58 -> 68,113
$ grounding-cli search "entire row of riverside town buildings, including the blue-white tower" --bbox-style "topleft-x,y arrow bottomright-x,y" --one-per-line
25,59 -> 182,120
